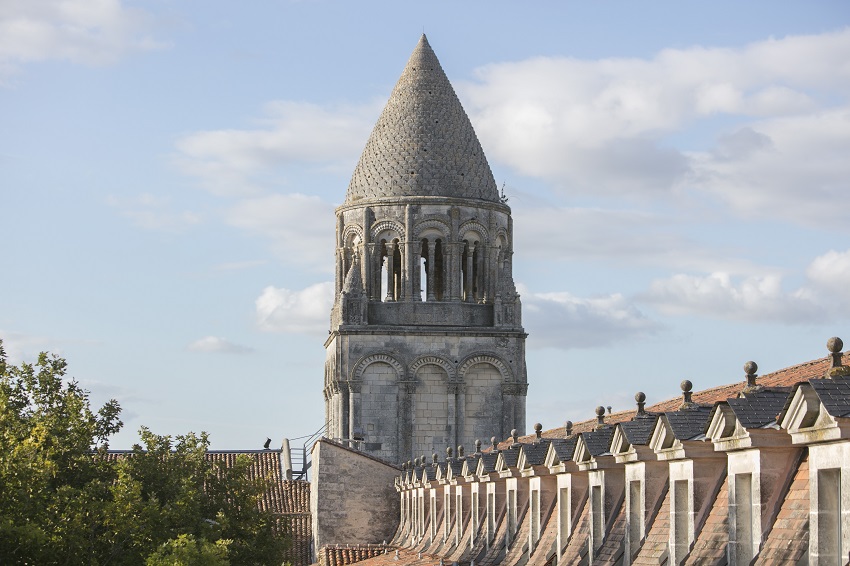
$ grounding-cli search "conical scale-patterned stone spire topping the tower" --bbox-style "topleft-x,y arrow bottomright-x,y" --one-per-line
346,34 -> 499,204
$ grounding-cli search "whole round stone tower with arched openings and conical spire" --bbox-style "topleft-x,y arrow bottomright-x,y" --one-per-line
324,35 -> 528,463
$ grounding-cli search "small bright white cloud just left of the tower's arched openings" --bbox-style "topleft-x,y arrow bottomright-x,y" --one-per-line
255,281 -> 334,336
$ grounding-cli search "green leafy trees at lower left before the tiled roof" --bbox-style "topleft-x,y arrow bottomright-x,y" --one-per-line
0,341 -> 285,565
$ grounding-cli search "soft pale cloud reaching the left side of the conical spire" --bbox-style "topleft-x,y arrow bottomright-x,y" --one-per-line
175,101 -> 380,195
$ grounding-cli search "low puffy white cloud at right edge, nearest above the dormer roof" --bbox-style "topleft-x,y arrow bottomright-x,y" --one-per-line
639,250 -> 850,324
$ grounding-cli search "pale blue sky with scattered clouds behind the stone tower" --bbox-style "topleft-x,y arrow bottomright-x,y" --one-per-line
0,0 -> 850,448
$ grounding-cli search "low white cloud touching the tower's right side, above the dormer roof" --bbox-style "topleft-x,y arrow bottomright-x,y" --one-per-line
520,286 -> 661,350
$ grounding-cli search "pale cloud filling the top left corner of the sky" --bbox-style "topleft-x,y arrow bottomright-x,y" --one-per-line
0,0 -> 166,81
